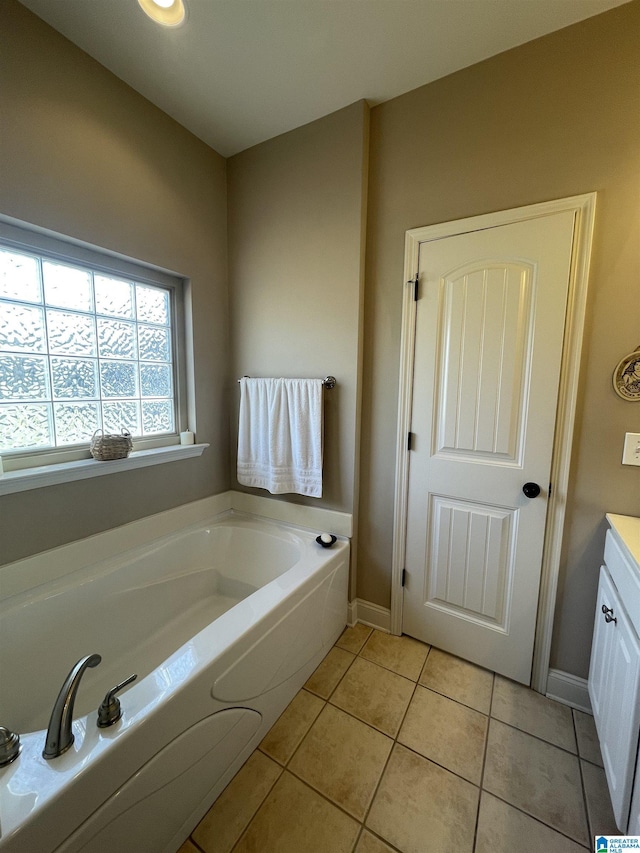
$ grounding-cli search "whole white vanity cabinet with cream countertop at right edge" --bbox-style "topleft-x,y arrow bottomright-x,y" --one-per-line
589,515 -> 640,835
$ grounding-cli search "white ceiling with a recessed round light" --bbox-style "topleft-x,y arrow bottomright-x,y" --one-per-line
21,0 -> 627,157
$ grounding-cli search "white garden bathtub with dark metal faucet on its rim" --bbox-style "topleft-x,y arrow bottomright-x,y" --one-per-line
0,512 -> 349,853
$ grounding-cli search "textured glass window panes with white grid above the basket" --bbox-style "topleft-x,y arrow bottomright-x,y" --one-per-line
0,244 -> 177,453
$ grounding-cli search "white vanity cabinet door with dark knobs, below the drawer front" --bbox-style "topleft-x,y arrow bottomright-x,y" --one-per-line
589,566 -> 640,832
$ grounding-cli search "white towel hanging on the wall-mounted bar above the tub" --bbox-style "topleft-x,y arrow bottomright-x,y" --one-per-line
238,377 -> 322,498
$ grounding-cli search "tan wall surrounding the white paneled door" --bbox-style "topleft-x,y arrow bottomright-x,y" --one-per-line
357,2 -> 640,676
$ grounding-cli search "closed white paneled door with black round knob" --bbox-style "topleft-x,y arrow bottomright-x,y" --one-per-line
402,211 -> 574,684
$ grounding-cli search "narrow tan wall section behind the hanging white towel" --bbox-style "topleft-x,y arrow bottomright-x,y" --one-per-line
228,101 -> 369,512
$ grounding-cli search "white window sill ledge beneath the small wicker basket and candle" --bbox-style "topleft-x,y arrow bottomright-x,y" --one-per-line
0,444 -> 209,495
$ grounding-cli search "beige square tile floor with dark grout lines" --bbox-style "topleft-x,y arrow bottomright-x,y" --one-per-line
180,625 -> 618,853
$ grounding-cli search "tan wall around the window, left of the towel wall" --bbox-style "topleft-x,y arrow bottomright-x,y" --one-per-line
0,0 -> 229,562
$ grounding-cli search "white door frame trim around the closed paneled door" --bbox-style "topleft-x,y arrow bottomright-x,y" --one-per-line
391,193 -> 596,693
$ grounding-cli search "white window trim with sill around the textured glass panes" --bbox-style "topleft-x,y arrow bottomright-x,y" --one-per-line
0,214 -> 196,482
